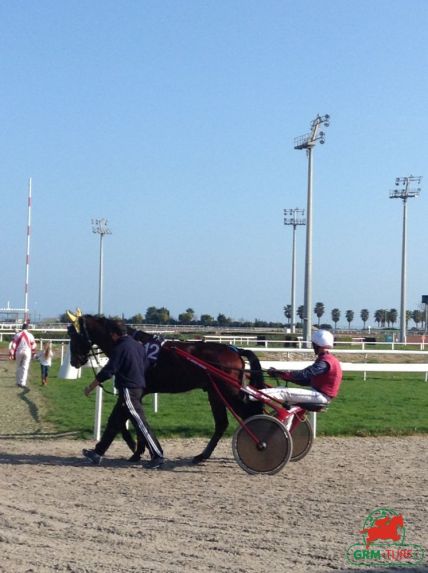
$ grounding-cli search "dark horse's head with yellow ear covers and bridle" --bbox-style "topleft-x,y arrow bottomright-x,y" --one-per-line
67,310 -> 113,368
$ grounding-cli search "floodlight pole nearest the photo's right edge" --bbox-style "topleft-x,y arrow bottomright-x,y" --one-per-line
389,175 -> 422,343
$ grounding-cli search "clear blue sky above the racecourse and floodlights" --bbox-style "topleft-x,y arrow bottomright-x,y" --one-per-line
0,0 -> 428,322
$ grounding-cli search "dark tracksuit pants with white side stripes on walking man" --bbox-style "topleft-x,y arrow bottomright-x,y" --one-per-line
95,388 -> 163,459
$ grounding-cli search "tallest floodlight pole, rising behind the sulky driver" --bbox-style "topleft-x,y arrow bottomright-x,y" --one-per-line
294,114 -> 330,347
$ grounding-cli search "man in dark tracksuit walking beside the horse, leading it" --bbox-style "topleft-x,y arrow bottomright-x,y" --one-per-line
82,322 -> 164,468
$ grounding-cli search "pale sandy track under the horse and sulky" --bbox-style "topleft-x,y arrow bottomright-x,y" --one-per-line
0,362 -> 428,573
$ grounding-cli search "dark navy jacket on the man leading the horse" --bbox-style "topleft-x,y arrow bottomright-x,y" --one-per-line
96,336 -> 147,390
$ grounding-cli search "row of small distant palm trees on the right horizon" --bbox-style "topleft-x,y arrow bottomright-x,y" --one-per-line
284,302 -> 425,329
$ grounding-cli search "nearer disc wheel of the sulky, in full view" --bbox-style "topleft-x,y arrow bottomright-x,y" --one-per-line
232,414 -> 293,474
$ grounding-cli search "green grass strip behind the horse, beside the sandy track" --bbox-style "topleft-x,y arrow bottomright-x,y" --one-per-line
32,361 -> 428,438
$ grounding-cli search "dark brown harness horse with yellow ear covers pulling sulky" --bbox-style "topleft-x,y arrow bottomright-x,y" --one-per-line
67,311 -> 266,464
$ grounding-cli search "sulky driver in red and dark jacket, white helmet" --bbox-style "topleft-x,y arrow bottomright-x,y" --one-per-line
263,330 -> 342,405
